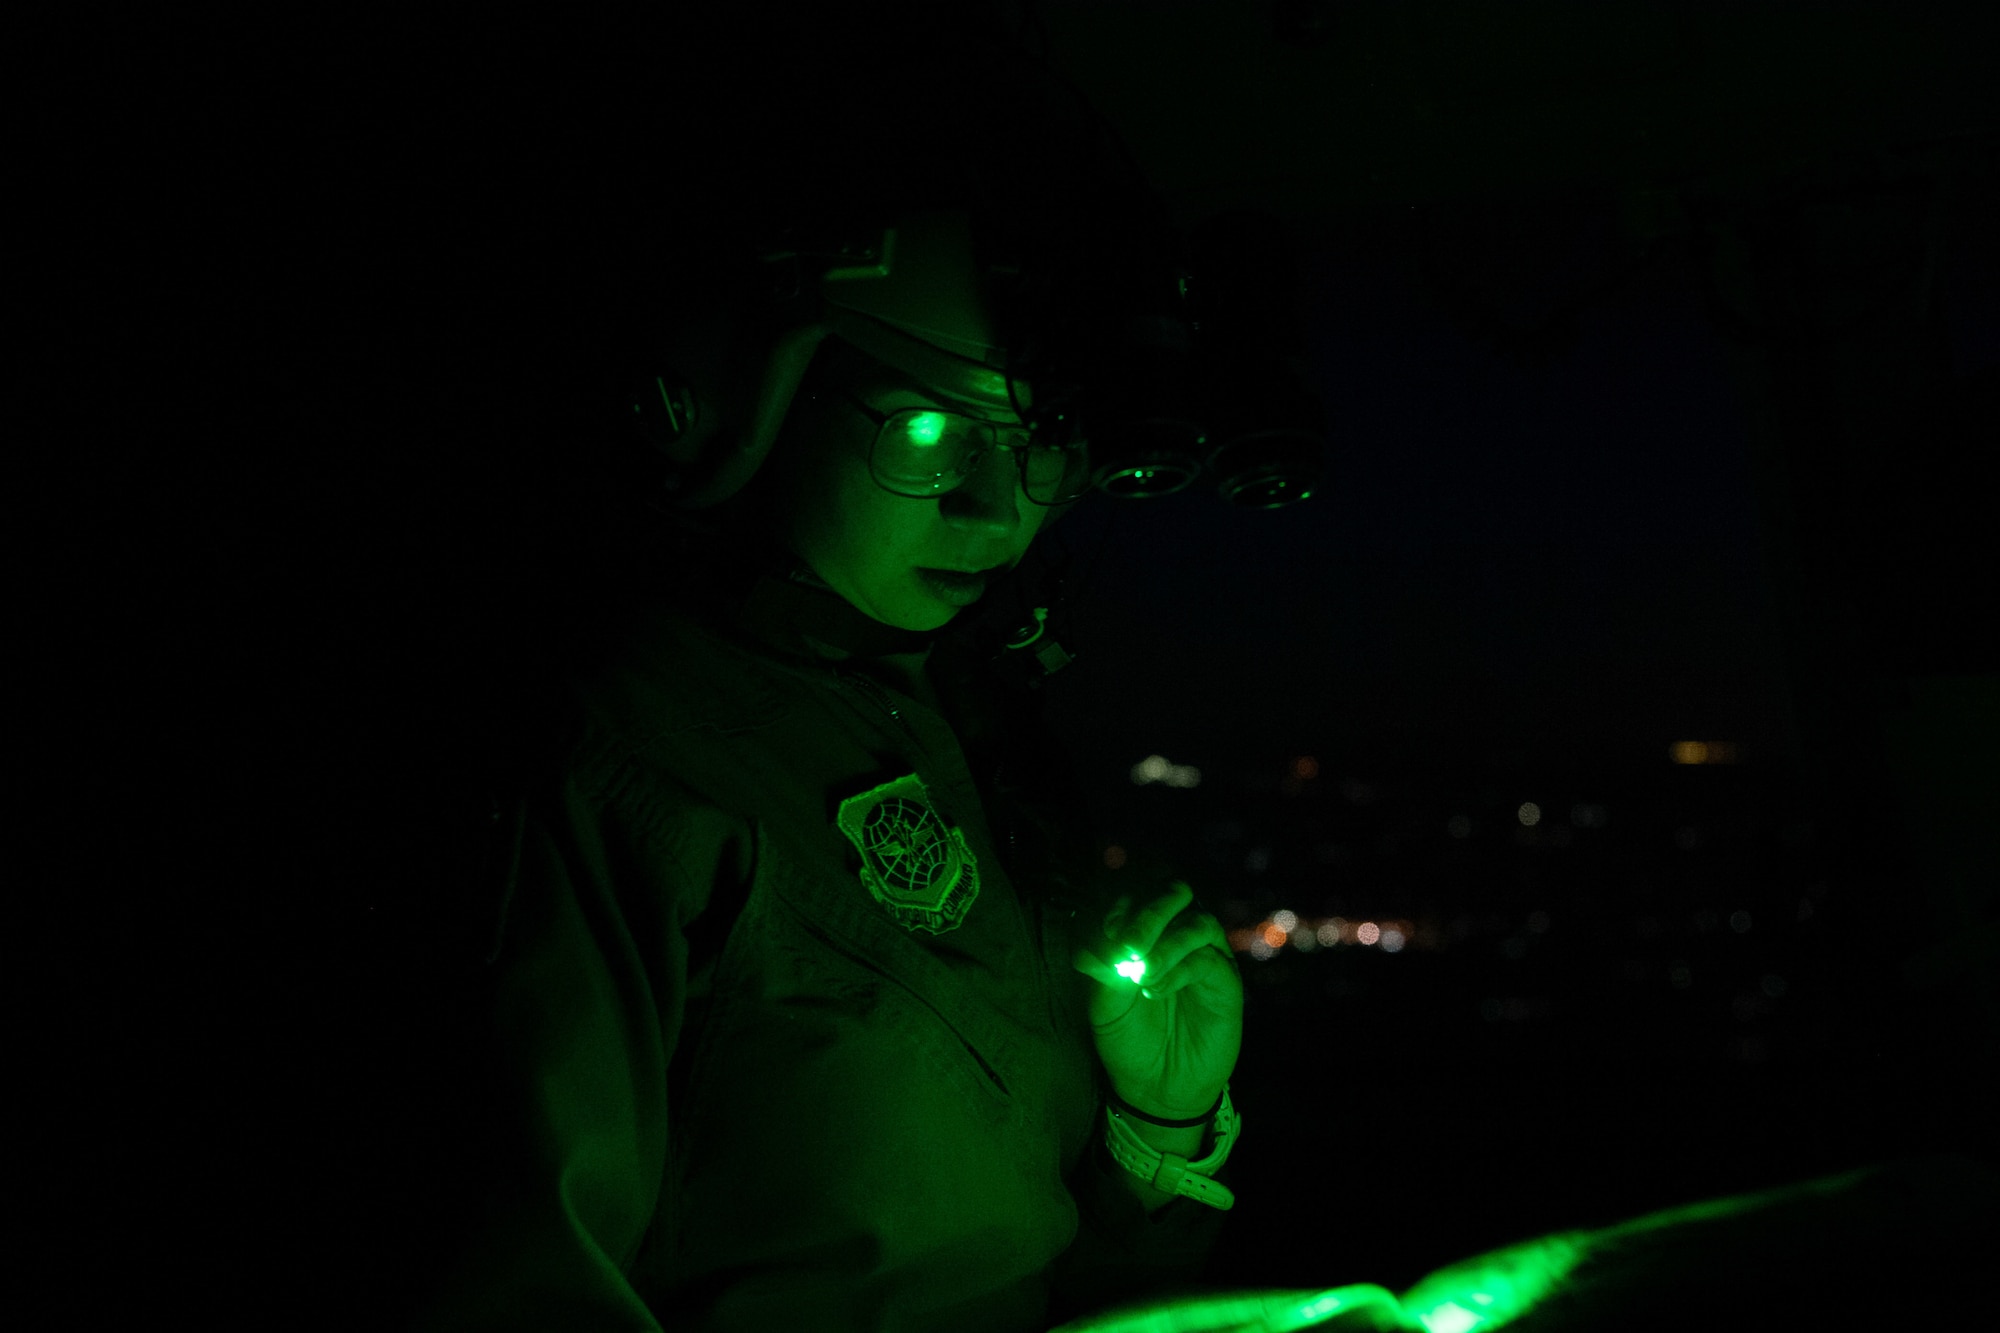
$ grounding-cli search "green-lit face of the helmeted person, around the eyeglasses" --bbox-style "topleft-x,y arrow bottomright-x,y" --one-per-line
786,348 -> 1070,632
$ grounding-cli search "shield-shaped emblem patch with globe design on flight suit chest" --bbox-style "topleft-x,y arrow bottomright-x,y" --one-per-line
836,773 -> 980,935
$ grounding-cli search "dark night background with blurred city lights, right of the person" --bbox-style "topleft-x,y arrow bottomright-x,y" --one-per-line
1016,4 -> 2000,1287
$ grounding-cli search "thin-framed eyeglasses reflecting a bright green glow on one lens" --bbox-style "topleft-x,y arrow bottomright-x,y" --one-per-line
816,392 -> 1090,506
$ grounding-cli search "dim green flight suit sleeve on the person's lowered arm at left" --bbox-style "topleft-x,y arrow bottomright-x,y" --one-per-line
408,756 -> 748,1333
